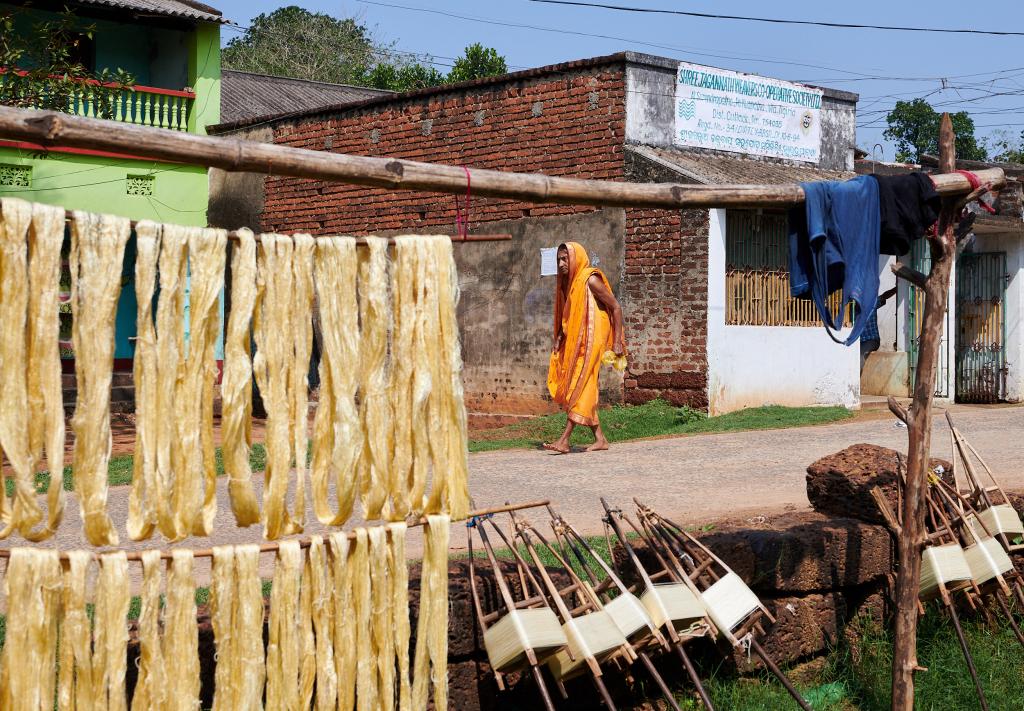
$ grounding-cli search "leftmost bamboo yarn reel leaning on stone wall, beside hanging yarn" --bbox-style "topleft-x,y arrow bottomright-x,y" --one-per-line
466,515 -> 568,711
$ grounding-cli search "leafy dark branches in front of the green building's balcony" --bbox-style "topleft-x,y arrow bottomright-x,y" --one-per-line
0,8 -> 135,118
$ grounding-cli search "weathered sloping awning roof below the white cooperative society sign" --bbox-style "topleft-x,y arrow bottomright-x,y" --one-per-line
629,145 -> 854,185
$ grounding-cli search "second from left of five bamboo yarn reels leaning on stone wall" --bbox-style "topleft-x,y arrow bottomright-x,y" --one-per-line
509,511 -> 637,711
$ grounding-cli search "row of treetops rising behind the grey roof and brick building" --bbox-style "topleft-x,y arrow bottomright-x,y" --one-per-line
221,5 -> 508,91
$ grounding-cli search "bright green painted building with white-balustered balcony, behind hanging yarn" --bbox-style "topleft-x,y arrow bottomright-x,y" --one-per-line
0,0 -> 224,379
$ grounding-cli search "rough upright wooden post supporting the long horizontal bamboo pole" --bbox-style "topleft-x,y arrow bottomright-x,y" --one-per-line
892,114 -> 957,711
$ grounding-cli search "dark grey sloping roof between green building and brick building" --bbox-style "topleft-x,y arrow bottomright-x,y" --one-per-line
220,70 -> 392,124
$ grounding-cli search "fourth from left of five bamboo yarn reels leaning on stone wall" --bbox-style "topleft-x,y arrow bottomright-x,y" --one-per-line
548,505 -> 711,709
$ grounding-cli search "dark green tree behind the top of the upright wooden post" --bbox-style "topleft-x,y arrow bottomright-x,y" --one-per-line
884,98 -> 988,163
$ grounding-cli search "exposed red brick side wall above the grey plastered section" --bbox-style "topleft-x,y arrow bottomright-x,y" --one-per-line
261,62 -> 626,234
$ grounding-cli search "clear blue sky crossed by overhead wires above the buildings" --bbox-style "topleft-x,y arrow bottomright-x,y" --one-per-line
213,0 -> 1024,160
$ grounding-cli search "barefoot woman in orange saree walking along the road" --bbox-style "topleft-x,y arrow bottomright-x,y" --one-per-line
544,242 -> 626,454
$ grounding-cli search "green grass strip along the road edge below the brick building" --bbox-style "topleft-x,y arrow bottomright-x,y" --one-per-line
469,400 -> 853,452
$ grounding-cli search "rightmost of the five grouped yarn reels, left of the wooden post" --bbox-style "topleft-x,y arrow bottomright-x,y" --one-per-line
634,499 -> 812,711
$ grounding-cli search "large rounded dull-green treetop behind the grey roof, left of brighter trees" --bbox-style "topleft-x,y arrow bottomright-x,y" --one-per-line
220,5 -> 378,84
